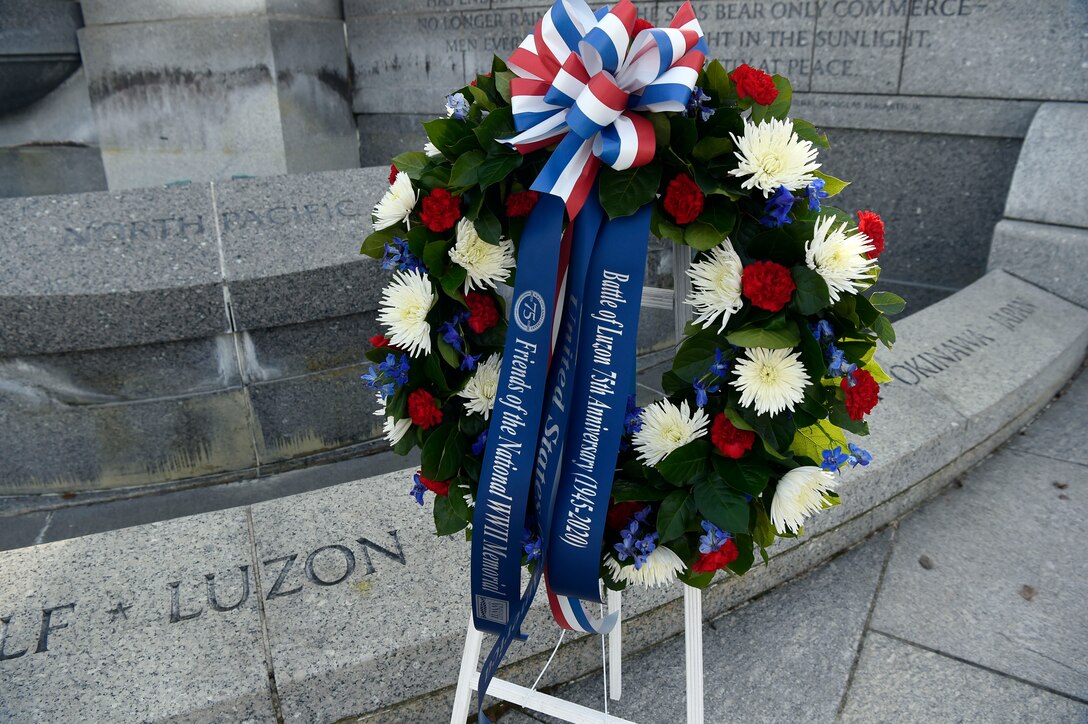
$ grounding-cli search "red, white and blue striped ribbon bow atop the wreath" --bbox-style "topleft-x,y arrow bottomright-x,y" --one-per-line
505,0 -> 706,219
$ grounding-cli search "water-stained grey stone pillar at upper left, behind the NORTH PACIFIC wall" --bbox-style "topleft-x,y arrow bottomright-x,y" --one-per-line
79,0 -> 359,189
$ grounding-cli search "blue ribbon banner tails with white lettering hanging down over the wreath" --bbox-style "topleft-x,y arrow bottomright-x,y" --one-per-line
471,189 -> 651,724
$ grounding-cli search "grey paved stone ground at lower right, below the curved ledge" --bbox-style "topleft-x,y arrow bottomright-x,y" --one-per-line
500,373 -> 1088,724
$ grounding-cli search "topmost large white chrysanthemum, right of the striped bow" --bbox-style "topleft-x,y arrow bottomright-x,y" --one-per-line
729,119 -> 820,197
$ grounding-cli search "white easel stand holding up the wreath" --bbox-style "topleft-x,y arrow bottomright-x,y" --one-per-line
449,244 -> 703,724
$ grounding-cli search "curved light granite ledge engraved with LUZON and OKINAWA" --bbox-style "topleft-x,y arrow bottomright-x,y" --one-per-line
0,271 -> 1088,722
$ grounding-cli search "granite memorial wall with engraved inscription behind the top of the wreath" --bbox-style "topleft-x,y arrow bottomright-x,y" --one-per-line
345,0 -> 1088,309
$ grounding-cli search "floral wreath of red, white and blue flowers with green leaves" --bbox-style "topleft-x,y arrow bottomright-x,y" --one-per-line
362,33 -> 904,589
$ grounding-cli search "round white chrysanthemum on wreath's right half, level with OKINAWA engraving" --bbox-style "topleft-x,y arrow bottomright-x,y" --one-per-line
730,347 -> 809,415
